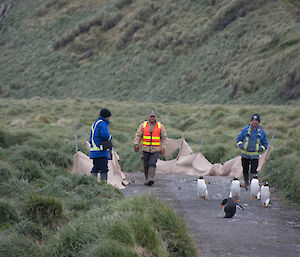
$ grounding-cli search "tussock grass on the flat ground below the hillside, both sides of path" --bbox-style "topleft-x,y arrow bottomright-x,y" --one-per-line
0,98 -> 300,256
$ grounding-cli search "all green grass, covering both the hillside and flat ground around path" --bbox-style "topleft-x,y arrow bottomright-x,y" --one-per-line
0,0 -> 300,253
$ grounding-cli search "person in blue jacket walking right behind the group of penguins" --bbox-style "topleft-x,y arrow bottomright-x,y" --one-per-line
236,113 -> 268,187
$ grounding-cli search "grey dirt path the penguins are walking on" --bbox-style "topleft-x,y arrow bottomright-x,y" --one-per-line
123,172 -> 300,257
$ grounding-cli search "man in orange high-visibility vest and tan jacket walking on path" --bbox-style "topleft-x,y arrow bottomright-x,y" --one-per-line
134,110 -> 167,186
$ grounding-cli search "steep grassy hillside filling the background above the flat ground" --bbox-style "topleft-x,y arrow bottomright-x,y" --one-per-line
0,0 -> 300,104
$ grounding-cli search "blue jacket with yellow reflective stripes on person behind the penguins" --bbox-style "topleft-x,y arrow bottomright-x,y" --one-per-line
236,124 -> 268,159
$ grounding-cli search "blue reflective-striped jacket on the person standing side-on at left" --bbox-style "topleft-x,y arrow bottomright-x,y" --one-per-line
90,116 -> 112,159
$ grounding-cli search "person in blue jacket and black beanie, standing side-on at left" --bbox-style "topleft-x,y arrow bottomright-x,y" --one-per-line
90,109 -> 112,182
